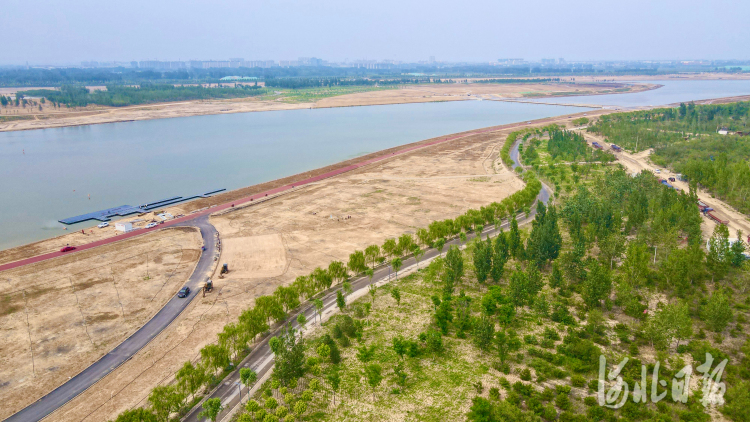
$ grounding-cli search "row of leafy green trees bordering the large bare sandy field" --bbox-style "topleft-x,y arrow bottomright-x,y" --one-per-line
107,166 -> 541,422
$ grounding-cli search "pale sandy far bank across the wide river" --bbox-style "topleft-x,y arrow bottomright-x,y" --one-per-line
0,83 -> 647,132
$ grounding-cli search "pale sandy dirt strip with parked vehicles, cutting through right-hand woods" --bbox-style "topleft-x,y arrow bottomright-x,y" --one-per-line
582,132 -> 750,240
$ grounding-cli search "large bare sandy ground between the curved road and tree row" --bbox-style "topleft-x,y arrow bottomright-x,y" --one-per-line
25,112 -> 612,421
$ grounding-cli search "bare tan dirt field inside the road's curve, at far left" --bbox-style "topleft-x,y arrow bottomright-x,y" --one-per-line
0,228 -> 202,419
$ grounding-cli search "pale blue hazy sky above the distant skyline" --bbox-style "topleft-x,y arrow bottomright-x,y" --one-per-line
5,0 -> 750,64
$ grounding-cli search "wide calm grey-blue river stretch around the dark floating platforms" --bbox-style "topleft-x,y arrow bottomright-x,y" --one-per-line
0,101 -> 585,249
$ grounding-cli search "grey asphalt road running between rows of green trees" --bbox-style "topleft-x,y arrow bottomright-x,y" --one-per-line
182,141 -> 551,422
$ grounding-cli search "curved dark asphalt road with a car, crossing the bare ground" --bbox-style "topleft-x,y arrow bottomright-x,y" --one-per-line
6,216 -> 218,422
